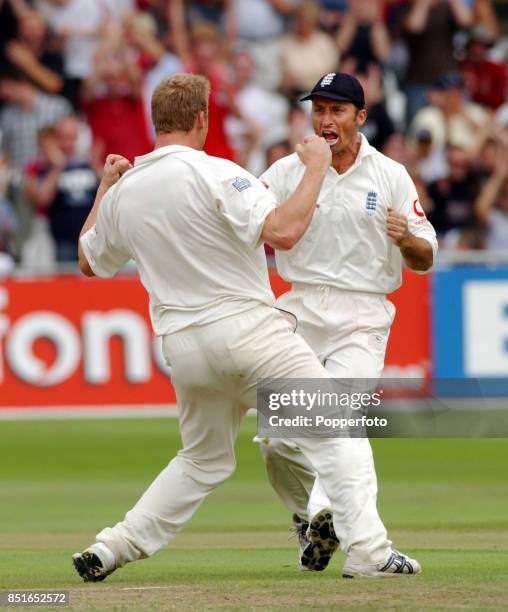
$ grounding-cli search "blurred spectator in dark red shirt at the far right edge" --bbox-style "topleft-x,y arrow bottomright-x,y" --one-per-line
460,26 -> 506,109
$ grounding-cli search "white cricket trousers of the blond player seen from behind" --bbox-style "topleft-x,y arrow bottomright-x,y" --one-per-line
96,305 -> 389,567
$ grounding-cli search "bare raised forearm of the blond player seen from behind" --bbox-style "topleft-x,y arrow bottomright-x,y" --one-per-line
261,167 -> 326,251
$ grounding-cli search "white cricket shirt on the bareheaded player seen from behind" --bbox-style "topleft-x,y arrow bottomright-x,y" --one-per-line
81,145 -> 276,335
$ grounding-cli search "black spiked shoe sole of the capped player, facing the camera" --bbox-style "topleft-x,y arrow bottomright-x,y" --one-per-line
300,508 -> 339,572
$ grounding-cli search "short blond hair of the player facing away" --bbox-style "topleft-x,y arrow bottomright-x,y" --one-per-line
152,74 -> 210,133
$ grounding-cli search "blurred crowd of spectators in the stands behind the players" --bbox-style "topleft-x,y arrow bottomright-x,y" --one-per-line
0,0 -> 508,272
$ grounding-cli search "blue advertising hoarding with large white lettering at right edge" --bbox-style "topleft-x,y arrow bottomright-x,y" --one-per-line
432,265 -> 508,396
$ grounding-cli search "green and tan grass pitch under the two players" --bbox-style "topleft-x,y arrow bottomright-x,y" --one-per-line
0,418 -> 508,611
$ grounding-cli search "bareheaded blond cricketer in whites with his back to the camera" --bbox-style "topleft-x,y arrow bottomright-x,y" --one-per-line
73,74 -> 418,581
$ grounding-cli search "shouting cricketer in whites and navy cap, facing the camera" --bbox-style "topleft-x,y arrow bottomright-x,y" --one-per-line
261,73 -> 437,570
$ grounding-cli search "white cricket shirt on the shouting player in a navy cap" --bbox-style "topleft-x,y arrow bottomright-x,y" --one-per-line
261,134 -> 437,294
